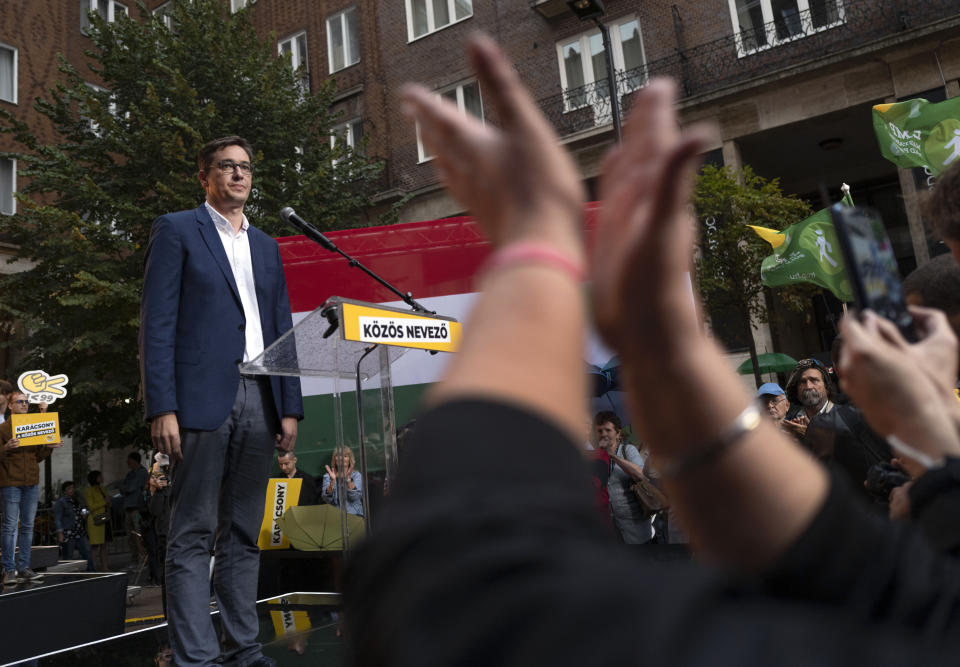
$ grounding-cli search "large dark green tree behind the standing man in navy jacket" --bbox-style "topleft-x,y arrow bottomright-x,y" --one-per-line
0,0 -> 390,447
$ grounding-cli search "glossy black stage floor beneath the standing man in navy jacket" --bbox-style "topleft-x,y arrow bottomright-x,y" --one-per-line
0,593 -> 343,667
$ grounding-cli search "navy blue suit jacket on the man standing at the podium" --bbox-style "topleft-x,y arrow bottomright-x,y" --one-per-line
140,205 -> 303,431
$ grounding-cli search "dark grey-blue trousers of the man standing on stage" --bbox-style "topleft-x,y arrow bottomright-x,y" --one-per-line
165,378 -> 279,667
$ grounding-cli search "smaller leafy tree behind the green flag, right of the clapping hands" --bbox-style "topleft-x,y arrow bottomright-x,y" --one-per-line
693,165 -> 818,332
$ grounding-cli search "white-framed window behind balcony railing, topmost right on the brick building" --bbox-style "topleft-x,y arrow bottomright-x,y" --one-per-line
728,0 -> 844,56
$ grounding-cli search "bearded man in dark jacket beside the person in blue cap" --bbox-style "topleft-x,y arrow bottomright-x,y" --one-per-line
787,359 -> 893,504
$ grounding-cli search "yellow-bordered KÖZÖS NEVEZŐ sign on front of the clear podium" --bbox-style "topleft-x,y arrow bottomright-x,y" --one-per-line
343,302 -> 463,352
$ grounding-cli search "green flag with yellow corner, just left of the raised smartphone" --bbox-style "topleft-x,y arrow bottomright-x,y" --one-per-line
747,183 -> 853,301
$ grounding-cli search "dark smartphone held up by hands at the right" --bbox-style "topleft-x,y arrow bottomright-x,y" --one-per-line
830,204 -> 917,342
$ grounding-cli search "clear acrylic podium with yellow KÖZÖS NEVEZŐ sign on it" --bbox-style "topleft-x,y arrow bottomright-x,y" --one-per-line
240,296 -> 461,553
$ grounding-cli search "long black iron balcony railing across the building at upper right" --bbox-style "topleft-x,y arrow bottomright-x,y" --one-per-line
539,0 -> 960,136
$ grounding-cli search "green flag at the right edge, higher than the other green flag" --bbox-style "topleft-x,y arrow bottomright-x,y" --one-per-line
873,97 -> 960,176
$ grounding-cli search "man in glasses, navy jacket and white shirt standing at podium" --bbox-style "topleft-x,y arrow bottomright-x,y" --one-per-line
140,137 -> 303,667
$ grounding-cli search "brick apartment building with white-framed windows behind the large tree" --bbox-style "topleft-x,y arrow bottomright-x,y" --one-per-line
0,0 -> 960,358
